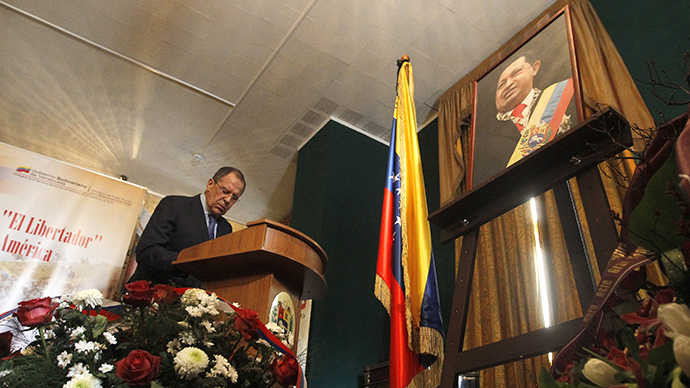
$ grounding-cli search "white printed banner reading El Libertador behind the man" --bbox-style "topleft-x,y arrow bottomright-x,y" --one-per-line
0,143 -> 146,312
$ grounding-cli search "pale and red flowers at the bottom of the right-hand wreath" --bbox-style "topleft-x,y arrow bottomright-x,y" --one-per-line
539,288 -> 690,388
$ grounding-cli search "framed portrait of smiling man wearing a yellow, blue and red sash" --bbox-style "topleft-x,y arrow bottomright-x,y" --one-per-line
468,7 -> 583,188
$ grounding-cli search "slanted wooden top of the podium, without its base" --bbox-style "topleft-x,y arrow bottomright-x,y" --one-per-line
173,219 -> 328,300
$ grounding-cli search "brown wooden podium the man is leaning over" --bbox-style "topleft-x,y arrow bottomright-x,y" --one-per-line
173,219 -> 328,344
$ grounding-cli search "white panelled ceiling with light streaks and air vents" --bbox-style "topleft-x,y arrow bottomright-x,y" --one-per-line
0,0 -> 552,223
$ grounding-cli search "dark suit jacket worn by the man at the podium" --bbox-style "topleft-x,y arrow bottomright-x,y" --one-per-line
129,194 -> 232,287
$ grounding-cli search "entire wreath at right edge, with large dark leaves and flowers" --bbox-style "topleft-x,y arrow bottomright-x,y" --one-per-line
539,104 -> 690,388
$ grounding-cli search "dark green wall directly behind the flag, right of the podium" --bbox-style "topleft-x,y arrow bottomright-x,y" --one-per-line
291,121 -> 454,388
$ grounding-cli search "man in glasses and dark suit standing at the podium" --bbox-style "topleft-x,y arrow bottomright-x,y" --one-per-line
129,167 -> 245,288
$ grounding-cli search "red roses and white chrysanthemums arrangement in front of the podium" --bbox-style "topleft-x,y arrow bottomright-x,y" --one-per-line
0,281 -> 299,388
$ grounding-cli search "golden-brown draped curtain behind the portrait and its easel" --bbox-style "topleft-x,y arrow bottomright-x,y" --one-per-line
439,0 -> 654,388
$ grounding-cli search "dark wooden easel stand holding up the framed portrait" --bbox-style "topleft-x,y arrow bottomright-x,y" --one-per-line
429,108 -> 632,388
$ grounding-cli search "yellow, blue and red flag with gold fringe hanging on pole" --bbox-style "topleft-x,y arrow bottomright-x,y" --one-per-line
374,59 -> 443,388
